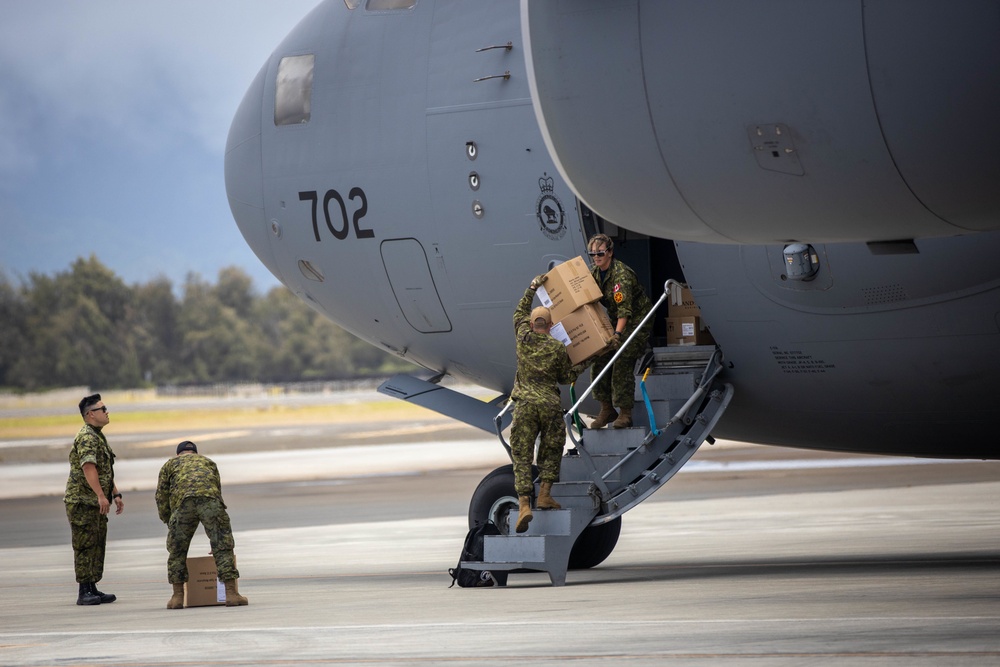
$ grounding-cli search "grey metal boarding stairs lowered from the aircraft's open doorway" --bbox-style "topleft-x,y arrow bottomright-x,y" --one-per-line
461,281 -> 733,586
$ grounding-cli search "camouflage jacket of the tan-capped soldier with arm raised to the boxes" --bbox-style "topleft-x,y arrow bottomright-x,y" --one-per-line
510,288 -> 582,409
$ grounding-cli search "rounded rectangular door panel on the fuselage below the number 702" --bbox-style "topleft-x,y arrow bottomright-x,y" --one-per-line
379,239 -> 451,333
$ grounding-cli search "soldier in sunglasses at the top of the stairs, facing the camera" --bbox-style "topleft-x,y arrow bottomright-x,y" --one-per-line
587,234 -> 653,428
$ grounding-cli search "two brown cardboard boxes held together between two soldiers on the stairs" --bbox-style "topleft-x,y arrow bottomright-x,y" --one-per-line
537,257 -> 615,364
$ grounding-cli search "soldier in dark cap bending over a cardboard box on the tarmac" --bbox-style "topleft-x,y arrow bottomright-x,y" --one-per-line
156,440 -> 247,609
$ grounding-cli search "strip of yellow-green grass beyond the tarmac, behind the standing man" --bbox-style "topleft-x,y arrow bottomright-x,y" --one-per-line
0,401 -> 447,440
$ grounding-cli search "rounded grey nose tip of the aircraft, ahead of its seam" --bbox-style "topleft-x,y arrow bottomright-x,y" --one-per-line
225,65 -> 281,280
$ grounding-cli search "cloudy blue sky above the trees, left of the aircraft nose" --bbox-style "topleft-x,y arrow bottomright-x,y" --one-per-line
0,0 -> 319,292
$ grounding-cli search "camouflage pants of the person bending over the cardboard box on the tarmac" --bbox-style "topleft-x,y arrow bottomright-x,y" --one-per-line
167,497 -> 240,584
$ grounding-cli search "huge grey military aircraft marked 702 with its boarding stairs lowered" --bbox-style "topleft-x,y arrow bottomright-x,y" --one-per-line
225,0 -> 1000,583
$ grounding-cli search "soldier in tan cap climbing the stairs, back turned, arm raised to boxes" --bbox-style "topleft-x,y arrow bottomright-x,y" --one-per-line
510,276 -> 583,533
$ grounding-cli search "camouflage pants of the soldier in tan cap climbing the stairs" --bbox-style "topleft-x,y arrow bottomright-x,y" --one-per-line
510,400 -> 566,496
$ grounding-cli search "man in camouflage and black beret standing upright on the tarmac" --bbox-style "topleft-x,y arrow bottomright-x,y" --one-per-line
63,394 -> 125,605
